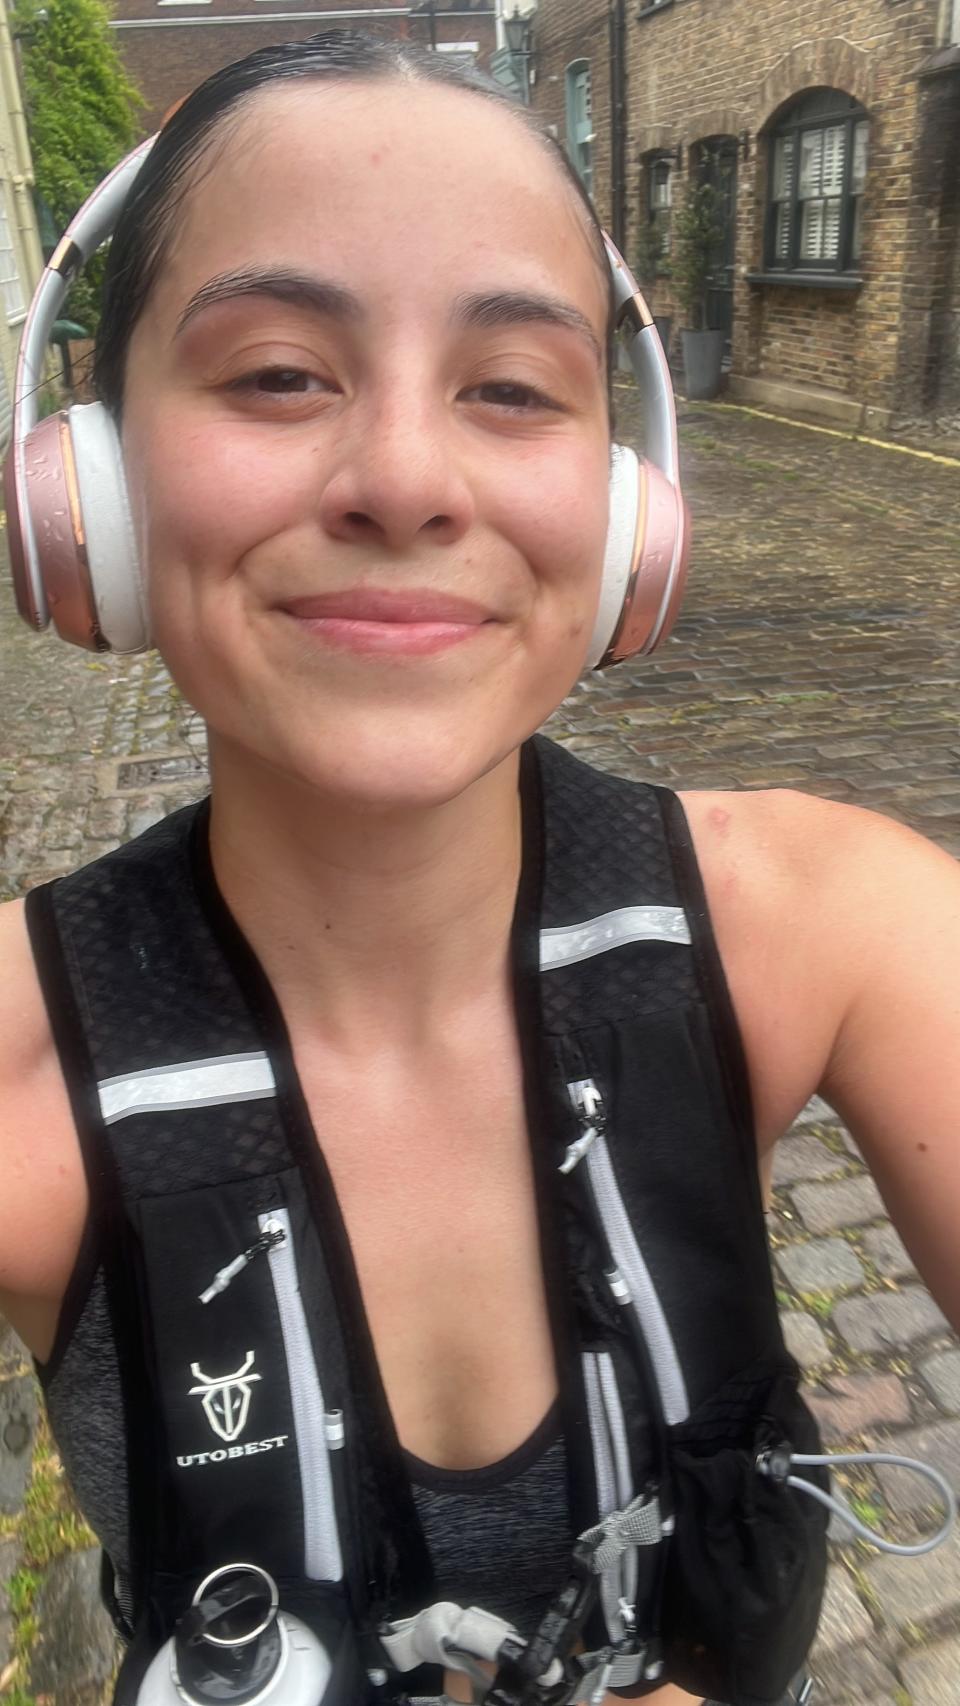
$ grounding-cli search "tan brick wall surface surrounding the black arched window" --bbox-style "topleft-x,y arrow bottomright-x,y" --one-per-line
535,0 -> 960,425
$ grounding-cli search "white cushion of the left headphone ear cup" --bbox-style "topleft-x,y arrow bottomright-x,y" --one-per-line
66,403 -> 150,652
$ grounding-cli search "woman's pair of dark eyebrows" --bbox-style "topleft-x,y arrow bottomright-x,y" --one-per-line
176,266 -> 604,368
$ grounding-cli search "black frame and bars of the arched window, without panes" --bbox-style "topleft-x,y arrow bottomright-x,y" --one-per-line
764,89 -> 870,280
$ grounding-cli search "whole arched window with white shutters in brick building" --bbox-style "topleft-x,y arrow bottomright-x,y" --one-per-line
766,89 -> 870,273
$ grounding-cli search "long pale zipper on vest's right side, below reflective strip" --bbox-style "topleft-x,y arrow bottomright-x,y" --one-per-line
566,1078 -> 691,1426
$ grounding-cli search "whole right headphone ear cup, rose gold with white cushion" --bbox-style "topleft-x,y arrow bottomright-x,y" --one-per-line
587,445 -> 691,669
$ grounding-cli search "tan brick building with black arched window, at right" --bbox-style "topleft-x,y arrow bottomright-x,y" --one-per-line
532,0 -> 960,428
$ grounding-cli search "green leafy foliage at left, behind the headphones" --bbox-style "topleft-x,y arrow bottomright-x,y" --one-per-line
14,0 -> 145,333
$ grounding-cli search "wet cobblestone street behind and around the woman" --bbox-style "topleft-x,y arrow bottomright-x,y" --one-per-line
0,389 -> 960,1706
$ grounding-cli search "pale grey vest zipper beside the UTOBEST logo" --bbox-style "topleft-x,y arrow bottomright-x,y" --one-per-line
257,1208 -> 343,1581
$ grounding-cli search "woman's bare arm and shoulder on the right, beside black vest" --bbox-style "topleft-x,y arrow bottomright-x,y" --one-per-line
684,792 -> 960,1327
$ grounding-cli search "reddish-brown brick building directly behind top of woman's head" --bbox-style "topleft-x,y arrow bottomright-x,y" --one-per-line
113,0 -> 496,135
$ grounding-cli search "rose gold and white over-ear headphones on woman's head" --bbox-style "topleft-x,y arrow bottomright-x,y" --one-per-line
3,138 -> 689,669
